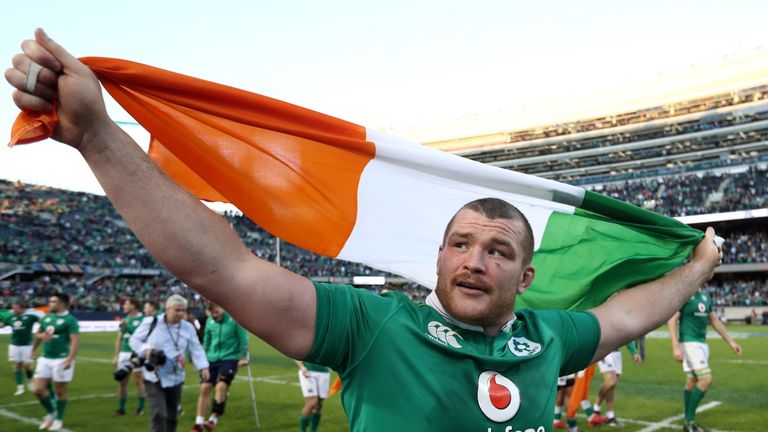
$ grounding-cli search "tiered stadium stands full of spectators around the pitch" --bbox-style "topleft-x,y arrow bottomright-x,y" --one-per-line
0,65 -> 768,310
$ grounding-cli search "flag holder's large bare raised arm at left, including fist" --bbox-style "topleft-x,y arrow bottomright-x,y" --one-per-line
5,29 -> 316,358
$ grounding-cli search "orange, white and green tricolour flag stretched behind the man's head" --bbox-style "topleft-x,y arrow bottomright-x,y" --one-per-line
13,57 -> 703,309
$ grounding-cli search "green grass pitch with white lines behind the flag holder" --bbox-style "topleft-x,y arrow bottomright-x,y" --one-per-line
0,325 -> 768,432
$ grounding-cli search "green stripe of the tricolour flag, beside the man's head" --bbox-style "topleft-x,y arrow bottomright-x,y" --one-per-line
516,192 -> 704,310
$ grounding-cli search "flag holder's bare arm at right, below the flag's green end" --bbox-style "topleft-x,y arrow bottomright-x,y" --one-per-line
592,228 -> 721,361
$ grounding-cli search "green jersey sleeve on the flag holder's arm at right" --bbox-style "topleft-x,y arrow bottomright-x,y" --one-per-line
542,311 -> 600,376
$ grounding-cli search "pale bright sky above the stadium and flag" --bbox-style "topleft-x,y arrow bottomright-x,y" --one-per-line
0,0 -> 768,193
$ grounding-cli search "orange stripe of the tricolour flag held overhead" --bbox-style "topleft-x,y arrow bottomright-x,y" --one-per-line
9,57 -> 375,256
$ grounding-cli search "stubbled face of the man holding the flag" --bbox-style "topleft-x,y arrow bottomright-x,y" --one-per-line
435,209 -> 534,327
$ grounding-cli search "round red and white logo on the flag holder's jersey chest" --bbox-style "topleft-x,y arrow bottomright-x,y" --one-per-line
477,371 -> 520,423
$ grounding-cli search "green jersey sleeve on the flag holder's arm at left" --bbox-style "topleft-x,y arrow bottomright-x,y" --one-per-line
302,283 -> 401,372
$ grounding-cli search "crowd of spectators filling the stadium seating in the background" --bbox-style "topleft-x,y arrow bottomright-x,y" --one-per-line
0,159 -> 768,311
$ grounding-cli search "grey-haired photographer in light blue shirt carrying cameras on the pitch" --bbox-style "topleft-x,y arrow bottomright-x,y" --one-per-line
130,294 -> 209,432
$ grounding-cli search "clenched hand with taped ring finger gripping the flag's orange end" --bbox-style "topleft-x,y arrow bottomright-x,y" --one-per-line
5,29 -> 112,148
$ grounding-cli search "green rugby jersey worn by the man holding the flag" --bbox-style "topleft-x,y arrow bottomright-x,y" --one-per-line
306,283 -> 600,432
